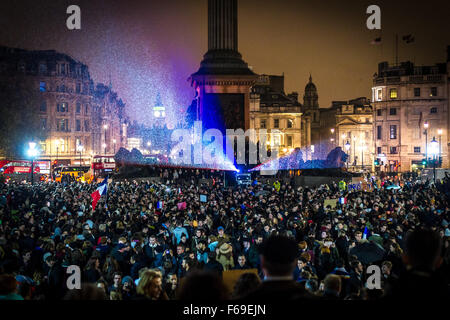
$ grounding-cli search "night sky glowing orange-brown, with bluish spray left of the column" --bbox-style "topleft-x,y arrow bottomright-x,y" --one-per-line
0,0 -> 450,127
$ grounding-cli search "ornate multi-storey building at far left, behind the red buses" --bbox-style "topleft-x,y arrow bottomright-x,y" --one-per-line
0,47 -> 126,164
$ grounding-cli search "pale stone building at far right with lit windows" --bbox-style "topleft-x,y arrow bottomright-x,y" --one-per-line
372,47 -> 450,171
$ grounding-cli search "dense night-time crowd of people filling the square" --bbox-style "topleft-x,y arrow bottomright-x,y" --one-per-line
0,169 -> 450,301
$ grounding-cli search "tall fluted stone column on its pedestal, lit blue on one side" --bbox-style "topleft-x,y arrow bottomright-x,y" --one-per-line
189,0 -> 257,132
